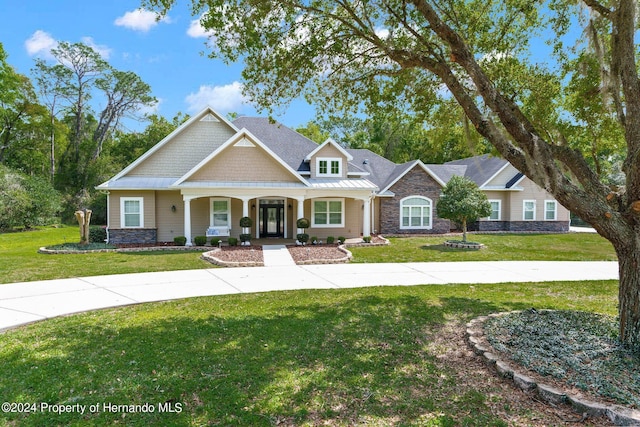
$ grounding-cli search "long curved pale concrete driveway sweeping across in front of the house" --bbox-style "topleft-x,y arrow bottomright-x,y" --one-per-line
0,260 -> 618,330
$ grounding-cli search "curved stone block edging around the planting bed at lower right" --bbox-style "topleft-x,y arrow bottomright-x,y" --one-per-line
465,311 -> 640,426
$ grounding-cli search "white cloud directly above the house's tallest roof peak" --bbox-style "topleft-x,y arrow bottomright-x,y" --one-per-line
185,82 -> 248,113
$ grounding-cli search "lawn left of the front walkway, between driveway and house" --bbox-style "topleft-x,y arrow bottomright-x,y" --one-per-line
0,227 -> 214,283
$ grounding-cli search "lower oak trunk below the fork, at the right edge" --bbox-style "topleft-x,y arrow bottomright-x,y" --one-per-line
616,234 -> 640,352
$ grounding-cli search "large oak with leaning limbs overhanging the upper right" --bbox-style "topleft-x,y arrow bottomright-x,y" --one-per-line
143,0 -> 640,348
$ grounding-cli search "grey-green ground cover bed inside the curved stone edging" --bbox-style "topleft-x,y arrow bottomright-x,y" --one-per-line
484,309 -> 640,409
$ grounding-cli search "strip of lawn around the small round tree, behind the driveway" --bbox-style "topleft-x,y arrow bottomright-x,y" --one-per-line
349,233 -> 618,263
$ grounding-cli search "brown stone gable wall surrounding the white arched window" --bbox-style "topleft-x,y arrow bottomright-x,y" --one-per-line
380,166 -> 451,235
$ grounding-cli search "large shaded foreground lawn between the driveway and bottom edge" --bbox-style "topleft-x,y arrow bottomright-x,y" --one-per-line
0,281 -> 617,426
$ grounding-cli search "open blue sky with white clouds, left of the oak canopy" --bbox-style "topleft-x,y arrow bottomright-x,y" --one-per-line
0,0 -> 315,130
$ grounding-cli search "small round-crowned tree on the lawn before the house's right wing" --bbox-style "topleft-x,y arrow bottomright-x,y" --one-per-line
437,176 -> 491,242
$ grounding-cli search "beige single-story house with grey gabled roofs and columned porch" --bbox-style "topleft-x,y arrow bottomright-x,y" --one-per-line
97,108 -> 569,244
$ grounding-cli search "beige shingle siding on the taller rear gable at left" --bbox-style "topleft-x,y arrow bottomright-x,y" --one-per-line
127,118 -> 235,177
